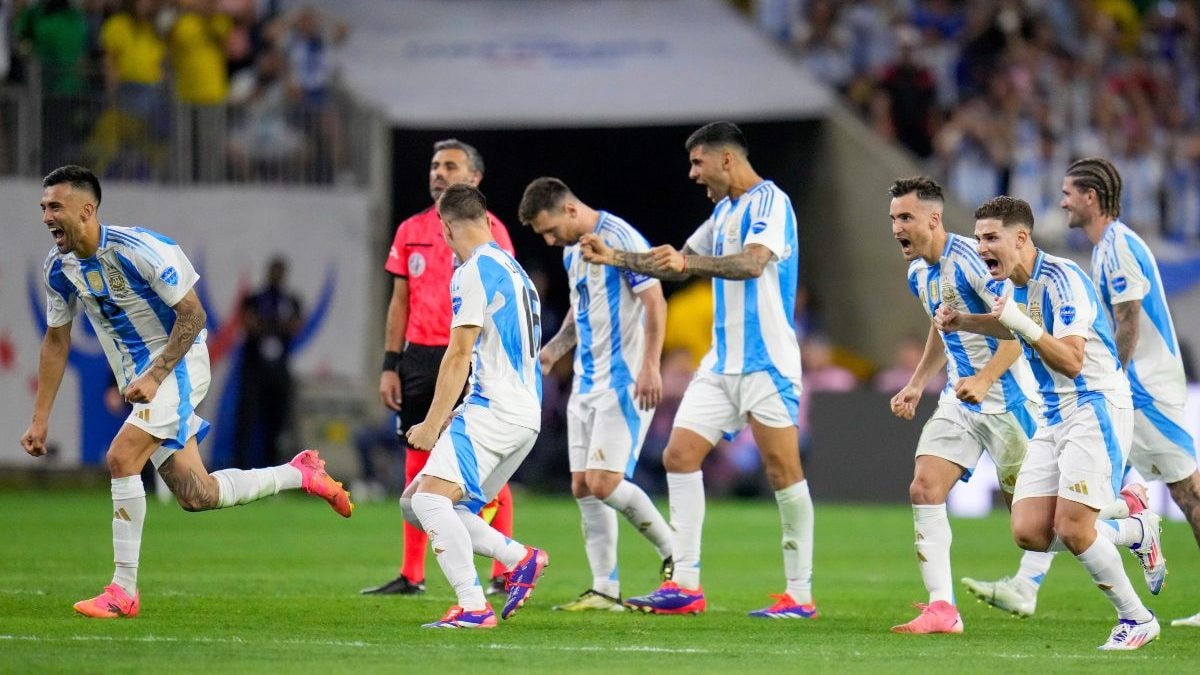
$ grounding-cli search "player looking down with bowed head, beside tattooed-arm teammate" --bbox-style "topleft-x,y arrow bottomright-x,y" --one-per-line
520,178 -> 671,611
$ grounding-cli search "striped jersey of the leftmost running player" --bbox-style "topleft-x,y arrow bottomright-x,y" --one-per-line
43,225 -> 206,389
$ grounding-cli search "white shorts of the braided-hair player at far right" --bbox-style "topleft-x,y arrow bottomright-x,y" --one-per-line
1129,402 -> 1196,484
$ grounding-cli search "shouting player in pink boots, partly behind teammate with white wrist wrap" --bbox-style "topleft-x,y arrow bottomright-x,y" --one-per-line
889,177 -> 1045,633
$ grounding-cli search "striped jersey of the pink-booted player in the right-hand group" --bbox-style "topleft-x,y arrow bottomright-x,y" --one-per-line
908,232 -> 1038,417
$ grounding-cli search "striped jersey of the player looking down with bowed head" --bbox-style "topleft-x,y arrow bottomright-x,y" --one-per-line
563,211 -> 659,394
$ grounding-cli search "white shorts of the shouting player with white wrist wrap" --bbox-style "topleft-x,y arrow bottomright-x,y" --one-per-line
1013,399 -> 1133,509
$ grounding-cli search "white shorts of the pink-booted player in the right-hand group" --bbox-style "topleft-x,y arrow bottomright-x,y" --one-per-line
917,401 -> 1038,495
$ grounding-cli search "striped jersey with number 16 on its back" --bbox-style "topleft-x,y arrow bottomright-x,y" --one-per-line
450,241 -> 541,431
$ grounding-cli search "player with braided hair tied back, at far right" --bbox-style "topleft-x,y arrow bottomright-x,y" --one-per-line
962,157 -> 1200,626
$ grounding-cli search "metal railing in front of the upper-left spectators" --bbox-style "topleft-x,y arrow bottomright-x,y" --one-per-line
0,64 -> 373,186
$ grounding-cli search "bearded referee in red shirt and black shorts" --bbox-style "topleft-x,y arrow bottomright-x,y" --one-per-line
362,138 -> 512,596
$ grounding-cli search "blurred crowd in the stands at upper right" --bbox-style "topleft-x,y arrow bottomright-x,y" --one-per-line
754,0 -> 1200,250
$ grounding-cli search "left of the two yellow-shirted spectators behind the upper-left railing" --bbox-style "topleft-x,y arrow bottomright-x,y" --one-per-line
88,0 -> 169,178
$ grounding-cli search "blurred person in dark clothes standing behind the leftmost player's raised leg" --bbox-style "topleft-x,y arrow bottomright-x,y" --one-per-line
234,257 -> 304,468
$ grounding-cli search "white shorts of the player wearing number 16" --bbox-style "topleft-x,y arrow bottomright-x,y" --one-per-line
414,404 -> 538,513
